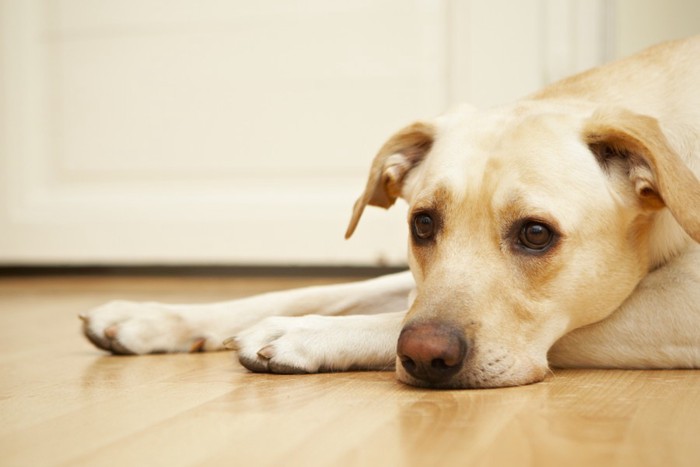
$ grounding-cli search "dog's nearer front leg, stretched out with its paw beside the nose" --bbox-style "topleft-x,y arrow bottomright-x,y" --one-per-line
228,311 -> 406,373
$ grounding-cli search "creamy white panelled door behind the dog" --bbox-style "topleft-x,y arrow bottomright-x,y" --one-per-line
0,0 -> 605,265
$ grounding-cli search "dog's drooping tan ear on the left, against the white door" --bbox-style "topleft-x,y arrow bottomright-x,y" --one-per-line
345,122 -> 435,238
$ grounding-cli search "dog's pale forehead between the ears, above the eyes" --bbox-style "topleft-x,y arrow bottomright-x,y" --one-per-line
418,104 -> 609,223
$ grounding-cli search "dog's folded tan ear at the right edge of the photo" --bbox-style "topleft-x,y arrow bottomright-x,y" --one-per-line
584,109 -> 700,242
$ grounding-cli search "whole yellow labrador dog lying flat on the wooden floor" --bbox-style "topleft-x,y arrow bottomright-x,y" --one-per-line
81,38 -> 700,388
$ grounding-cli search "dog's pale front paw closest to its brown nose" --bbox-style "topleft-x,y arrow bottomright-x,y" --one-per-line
232,315 -> 336,374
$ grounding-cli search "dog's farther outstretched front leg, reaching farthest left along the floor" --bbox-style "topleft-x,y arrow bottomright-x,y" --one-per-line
81,272 -> 413,354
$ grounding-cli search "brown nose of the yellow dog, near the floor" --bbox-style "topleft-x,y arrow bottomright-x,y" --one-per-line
396,322 -> 467,383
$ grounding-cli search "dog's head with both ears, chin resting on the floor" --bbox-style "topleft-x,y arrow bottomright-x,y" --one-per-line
347,102 -> 700,388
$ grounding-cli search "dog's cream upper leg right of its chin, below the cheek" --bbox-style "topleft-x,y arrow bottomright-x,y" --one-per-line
549,246 -> 700,368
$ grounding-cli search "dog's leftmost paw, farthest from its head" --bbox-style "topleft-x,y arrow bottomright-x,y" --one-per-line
80,301 -> 221,355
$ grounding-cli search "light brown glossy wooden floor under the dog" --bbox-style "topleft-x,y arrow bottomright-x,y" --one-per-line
0,277 -> 700,467
